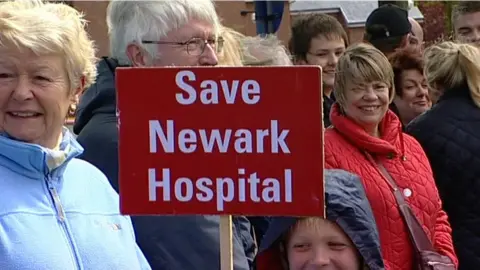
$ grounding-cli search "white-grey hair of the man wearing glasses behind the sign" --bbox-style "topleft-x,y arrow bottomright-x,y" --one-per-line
107,0 -> 220,65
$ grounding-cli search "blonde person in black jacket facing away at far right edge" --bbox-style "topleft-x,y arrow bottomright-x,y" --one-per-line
406,42 -> 480,270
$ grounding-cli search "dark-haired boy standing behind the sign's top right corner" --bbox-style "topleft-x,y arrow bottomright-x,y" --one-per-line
288,14 -> 348,127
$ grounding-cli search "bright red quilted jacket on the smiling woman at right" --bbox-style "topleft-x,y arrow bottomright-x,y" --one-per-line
325,104 -> 458,270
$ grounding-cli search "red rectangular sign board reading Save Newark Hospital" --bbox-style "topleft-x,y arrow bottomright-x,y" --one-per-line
116,67 -> 324,216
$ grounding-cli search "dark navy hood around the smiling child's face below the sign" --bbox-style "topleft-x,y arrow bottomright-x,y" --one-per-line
257,170 -> 385,270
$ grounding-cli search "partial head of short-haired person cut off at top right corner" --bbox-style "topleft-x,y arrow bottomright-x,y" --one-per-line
452,1 -> 480,47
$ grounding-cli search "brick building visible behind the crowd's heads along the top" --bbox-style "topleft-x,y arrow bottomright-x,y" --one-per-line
64,0 -> 424,56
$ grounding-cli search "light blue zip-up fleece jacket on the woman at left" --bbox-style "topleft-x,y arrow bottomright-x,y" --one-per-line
0,128 -> 151,270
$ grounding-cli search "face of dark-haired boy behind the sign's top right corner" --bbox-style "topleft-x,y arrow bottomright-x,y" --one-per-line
298,35 -> 345,88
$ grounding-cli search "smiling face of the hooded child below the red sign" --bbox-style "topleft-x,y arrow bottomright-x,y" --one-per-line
286,218 -> 361,270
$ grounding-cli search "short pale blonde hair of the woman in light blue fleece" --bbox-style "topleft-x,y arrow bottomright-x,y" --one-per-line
0,0 -> 97,90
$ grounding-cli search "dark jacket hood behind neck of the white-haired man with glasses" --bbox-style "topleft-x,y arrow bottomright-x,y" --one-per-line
73,57 -> 119,134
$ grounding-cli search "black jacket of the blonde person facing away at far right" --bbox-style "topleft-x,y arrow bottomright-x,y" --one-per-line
406,86 -> 480,270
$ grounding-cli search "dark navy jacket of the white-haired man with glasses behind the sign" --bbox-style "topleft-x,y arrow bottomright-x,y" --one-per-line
74,58 -> 255,270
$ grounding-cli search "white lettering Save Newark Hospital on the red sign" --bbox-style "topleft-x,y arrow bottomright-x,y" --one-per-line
148,70 -> 294,212
